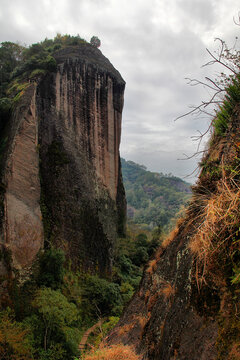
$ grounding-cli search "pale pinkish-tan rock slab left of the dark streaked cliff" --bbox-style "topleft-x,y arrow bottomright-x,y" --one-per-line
1,85 -> 43,269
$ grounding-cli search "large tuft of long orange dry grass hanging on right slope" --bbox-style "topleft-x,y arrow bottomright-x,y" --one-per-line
189,177 -> 240,282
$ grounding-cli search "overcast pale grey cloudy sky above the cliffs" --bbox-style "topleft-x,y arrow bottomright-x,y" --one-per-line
0,0 -> 240,182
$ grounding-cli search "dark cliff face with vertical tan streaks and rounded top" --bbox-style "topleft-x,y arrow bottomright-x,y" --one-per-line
37,45 -> 125,271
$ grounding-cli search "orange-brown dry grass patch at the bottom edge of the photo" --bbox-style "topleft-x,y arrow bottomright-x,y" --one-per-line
83,344 -> 141,360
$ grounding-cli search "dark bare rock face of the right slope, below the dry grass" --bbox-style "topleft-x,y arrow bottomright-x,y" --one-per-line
107,222 -> 218,360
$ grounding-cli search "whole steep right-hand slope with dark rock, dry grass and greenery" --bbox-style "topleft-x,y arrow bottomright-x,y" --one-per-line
107,86 -> 240,360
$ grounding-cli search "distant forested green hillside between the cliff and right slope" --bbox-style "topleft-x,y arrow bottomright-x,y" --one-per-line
121,159 -> 191,229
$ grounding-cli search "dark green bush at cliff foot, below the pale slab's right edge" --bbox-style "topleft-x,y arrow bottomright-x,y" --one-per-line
36,248 -> 65,289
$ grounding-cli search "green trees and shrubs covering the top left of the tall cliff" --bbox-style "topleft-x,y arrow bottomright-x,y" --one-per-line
0,34 -> 86,146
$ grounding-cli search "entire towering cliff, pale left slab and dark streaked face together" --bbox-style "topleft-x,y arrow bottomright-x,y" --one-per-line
1,44 -> 126,278
